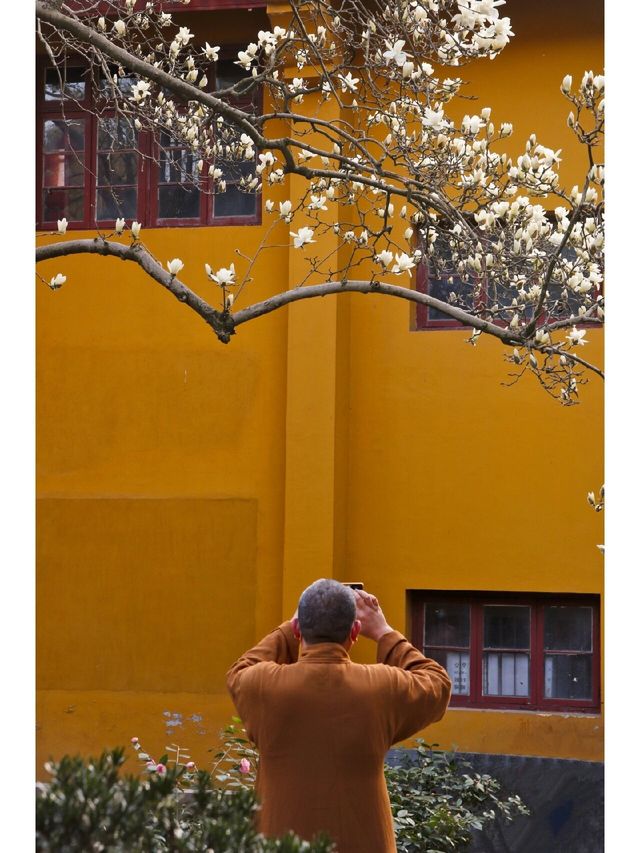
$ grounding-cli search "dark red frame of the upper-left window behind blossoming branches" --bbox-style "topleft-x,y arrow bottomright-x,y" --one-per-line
36,57 -> 262,231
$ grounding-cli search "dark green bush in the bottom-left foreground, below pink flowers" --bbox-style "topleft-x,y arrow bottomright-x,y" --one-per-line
36,749 -> 332,853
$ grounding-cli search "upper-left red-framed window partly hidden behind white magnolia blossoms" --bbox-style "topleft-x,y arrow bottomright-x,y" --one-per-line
36,58 -> 261,230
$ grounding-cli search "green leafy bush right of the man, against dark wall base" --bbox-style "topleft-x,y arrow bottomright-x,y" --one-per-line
385,740 -> 529,853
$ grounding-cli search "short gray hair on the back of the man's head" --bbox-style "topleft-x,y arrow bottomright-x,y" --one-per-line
298,578 -> 356,645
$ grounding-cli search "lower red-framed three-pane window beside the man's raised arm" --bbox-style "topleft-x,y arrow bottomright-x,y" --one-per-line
411,591 -> 600,713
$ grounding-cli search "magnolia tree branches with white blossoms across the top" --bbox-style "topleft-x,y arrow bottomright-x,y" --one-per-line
36,0 -> 604,404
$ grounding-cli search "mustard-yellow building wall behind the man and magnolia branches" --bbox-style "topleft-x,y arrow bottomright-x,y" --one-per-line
37,0 -> 603,772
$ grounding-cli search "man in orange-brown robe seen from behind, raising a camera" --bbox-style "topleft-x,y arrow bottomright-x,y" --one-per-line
227,579 -> 451,853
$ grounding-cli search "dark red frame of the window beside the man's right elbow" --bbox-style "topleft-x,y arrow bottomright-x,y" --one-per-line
409,590 -> 601,714
